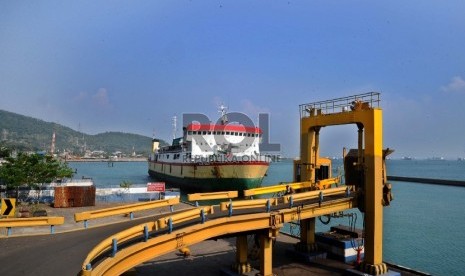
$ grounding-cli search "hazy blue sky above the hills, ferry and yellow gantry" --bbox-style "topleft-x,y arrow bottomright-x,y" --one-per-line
0,0 -> 465,158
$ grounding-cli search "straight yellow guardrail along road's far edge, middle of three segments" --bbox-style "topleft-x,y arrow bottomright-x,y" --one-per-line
74,197 -> 179,228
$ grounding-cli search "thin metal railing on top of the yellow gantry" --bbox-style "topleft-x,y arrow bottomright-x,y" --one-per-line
299,92 -> 380,119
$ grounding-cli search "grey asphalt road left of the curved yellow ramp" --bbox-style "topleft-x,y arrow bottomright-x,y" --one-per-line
0,218 -> 158,276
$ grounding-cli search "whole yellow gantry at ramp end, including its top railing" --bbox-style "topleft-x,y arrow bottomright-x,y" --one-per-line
294,92 -> 392,275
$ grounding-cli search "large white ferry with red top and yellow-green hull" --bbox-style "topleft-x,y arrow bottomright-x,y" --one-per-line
148,109 -> 270,192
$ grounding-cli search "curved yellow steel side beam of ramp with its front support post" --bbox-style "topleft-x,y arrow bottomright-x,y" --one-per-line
81,197 -> 356,276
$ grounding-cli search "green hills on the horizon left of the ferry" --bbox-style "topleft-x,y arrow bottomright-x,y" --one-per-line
0,110 -> 166,156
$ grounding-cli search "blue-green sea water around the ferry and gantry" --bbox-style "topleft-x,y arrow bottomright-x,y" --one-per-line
70,159 -> 465,275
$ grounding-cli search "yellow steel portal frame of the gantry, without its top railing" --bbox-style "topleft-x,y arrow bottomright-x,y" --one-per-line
301,105 -> 385,272
